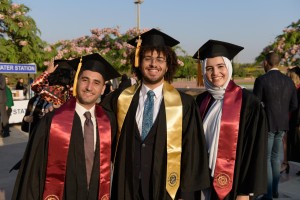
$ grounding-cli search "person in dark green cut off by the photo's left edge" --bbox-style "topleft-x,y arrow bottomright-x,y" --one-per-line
0,73 -> 9,137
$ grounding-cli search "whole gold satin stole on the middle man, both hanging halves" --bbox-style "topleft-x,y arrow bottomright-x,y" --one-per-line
117,82 -> 183,199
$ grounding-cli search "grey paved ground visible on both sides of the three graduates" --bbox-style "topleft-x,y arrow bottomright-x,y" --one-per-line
0,125 -> 300,200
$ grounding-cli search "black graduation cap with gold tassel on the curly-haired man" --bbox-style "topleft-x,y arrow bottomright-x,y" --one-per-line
128,28 -> 179,67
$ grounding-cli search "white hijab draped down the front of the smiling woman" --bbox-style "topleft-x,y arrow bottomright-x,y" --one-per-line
202,57 -> 232,177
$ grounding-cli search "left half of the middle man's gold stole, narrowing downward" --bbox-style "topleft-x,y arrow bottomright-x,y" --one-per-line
114,82 -> 140,163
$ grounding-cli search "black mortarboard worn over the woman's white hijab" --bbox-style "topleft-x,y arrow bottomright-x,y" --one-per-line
193,40 -> 244,60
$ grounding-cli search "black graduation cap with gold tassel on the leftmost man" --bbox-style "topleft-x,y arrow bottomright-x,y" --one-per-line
68,53 -> 121,96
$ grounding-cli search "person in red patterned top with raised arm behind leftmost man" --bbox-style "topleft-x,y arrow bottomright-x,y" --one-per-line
10,60 -> 75,172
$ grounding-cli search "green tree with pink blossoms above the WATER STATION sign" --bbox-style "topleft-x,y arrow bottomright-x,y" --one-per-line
0,0 -> 47,66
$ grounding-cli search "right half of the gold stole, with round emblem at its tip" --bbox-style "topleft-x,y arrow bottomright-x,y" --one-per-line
163,82 -> 183,199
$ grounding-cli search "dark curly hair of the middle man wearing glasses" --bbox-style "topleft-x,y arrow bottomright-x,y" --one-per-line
131,46 -> 179,83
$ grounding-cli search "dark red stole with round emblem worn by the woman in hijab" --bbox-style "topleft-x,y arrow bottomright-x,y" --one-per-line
200,81 -> 242,200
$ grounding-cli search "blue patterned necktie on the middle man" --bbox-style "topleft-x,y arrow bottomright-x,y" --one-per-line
142,90 -> 155,141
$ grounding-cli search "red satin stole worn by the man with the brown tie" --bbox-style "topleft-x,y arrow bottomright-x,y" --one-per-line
43,98 -> 111,200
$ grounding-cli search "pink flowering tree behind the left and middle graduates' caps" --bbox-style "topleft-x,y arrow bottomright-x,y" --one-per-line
45,27 -> 148,72
